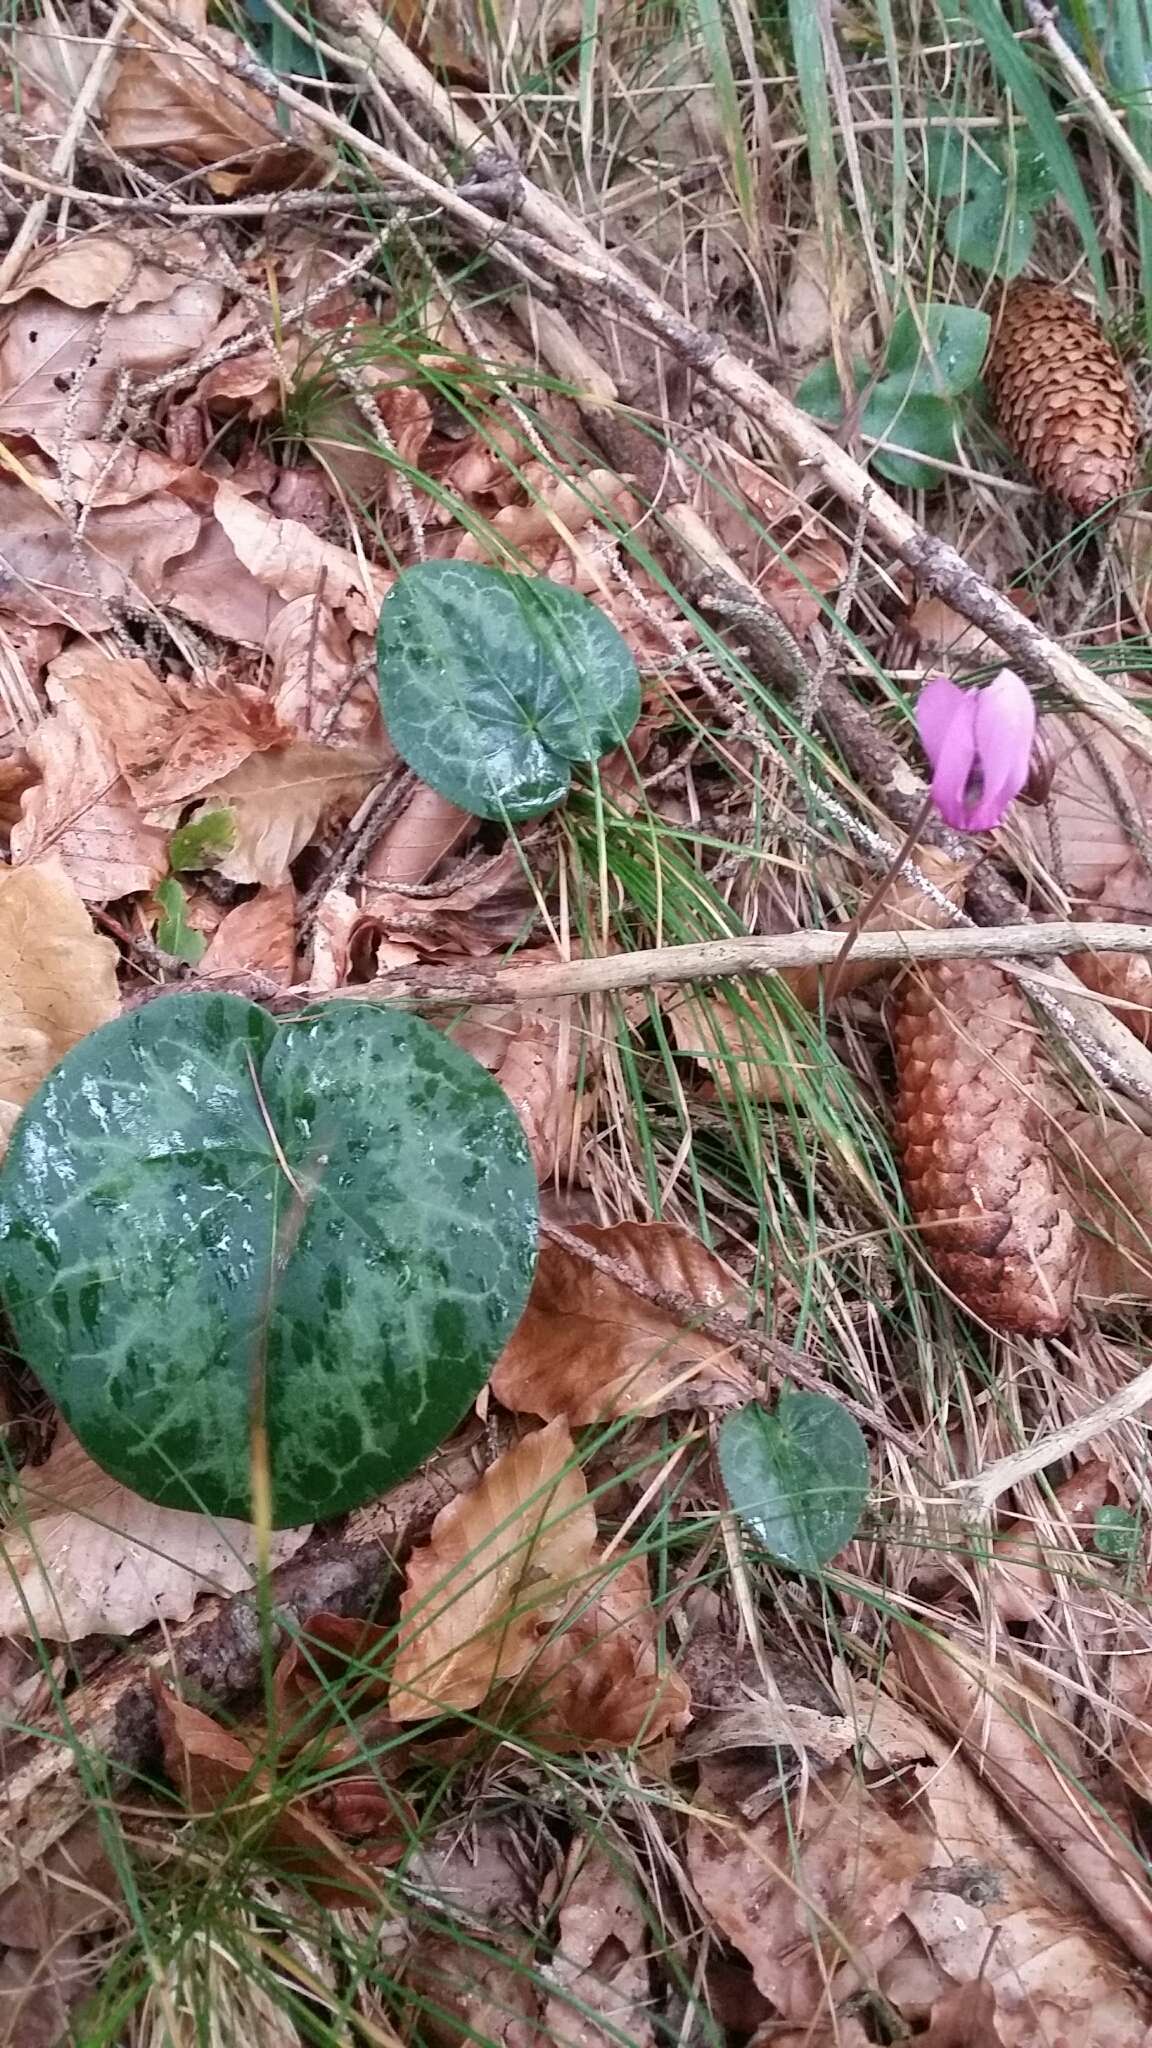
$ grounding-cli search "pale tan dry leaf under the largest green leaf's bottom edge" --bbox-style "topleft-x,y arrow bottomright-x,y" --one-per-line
0,1423 -> 307,1642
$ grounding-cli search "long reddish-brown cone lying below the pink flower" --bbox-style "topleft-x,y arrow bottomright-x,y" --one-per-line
896,961 -> 1078,1337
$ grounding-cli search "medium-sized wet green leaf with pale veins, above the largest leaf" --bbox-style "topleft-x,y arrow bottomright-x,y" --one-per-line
377,561 -> 640,821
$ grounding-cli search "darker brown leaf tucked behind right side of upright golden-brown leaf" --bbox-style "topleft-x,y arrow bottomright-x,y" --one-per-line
520,1556 -> 691,1749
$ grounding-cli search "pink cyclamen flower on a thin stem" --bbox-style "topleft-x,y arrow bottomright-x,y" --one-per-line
916,668 -> 1035,831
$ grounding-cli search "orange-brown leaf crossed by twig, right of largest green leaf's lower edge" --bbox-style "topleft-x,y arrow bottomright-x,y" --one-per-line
492,1223 -> 756,1427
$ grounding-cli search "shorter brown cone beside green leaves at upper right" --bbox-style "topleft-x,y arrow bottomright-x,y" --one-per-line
984,285 -> 1140,518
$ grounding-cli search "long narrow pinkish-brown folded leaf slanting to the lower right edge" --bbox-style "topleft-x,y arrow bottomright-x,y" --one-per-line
894,1628 -> 1152,1968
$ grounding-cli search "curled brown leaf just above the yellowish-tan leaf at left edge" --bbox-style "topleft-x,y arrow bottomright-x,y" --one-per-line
12,692 -> 168,903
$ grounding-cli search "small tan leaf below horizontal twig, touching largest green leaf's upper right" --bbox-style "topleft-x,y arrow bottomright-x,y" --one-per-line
449,995 -> 588,1182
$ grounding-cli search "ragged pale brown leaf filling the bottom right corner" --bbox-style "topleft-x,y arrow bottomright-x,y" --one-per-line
853,1686 -> 1152,2048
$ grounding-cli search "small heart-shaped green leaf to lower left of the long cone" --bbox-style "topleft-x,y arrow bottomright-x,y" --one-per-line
719,1386 -> 869,1571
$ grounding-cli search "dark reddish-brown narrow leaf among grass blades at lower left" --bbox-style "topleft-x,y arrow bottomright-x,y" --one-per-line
152,1677 -> 381,1909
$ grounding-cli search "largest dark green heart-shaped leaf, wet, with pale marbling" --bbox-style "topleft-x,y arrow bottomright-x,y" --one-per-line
0,995 -> 537,1526
